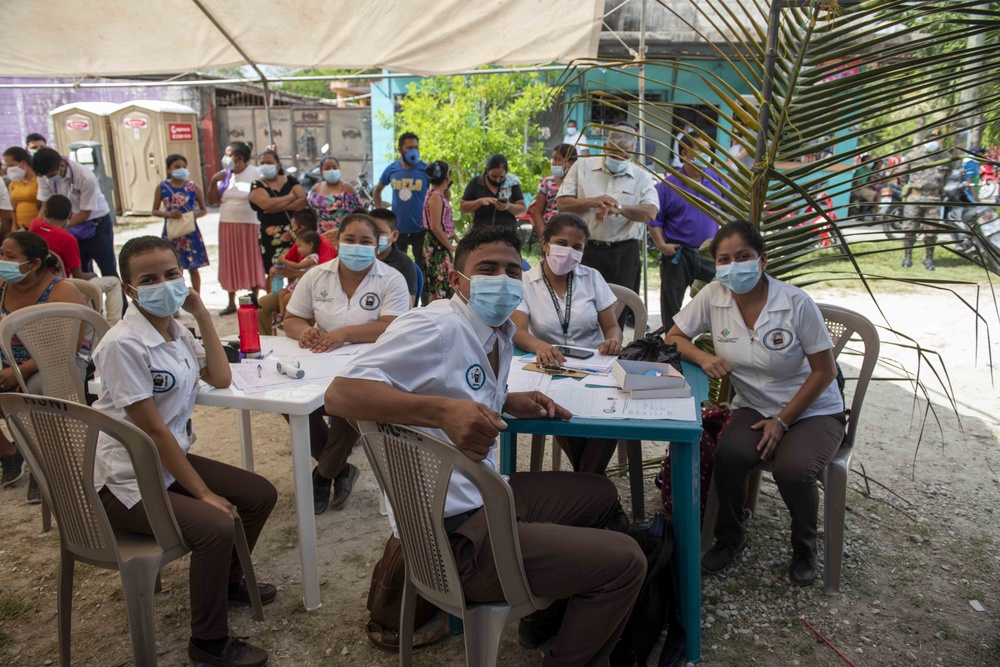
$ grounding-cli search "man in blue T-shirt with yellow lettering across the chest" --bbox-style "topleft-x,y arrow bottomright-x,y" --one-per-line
372,132 -> 430,273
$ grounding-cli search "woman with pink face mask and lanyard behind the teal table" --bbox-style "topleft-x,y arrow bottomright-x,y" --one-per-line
511,213 -> 622,475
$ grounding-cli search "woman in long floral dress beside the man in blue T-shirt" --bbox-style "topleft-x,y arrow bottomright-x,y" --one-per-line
423,160 -> 455,301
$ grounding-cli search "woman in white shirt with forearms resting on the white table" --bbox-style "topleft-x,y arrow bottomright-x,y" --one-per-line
284,213 -> 410,514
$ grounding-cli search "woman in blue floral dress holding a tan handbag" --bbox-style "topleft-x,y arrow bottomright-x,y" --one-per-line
153,158 -> 208,292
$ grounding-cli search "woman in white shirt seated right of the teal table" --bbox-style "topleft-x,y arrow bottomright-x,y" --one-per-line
667,221 -> 844,586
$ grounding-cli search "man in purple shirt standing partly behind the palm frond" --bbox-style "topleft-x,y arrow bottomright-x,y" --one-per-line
649,133 -> 726,331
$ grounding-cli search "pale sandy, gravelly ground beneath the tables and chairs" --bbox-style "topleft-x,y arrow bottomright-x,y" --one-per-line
0,218 -> 1000,667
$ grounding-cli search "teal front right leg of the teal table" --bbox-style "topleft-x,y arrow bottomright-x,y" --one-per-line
670,440 -> 701,662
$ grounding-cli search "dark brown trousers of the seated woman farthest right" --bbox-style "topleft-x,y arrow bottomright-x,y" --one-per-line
712,408 -> 844,556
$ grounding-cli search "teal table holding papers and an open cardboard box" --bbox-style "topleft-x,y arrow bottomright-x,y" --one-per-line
500,362 -> 708,662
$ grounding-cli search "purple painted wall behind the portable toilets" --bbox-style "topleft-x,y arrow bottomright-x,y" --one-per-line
0,77 -> 202,152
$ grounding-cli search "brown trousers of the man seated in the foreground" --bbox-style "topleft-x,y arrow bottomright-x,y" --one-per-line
451,472 -> 646,667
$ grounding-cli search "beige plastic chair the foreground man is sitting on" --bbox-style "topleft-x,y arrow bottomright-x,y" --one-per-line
357,422 -> 553,667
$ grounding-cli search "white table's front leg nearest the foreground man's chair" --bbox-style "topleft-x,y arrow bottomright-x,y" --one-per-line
288,415 -> 323,611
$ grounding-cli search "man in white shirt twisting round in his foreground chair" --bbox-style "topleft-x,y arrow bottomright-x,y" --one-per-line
326,225 -> 646,666
